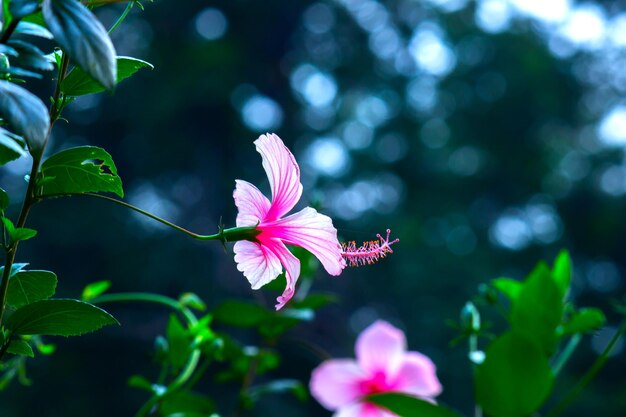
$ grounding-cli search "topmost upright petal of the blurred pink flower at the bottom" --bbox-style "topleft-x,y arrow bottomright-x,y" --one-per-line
355,320 -> 406,377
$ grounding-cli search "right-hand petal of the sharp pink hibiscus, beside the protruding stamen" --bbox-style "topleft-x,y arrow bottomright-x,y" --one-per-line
263,207 -> 346,275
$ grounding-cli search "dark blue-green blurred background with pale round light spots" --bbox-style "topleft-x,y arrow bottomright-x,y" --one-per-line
0,0 -> 626,417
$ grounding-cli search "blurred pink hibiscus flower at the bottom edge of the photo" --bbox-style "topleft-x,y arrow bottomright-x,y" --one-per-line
310,321 -> 441,417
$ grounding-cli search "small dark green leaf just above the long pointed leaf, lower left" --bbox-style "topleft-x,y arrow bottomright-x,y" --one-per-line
7,271 -> 57,308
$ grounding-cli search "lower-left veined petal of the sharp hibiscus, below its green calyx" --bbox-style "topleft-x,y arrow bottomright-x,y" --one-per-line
233,240 -> 282,290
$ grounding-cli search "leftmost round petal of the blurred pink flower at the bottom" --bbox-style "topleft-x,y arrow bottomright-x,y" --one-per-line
309,359 -> 365,410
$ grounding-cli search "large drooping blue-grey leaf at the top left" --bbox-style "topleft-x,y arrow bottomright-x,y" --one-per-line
42,0 -> 117,90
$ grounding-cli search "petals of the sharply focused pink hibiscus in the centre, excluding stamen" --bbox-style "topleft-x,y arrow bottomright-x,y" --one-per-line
233,134 -> 346,310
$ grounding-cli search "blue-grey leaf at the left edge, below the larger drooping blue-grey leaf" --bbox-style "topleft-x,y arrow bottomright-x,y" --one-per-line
0,80 -> 50,155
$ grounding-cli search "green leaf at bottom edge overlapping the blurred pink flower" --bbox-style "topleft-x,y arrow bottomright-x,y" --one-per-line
367,393 -> 460,417
